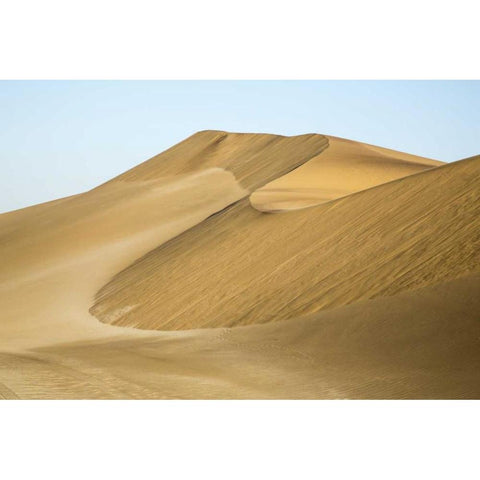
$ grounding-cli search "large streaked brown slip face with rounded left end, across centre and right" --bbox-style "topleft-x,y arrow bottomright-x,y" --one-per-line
91,156 -> 480,330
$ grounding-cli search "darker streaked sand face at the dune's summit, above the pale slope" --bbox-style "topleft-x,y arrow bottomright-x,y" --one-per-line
104,130 -> 328,191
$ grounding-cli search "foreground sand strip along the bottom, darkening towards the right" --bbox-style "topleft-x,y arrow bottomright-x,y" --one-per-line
0,274 -> 480,399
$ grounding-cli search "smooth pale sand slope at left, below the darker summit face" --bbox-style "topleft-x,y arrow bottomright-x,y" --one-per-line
0,168 -> 248,351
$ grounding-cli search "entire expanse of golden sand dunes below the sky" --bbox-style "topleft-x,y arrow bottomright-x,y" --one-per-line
0,130 -> 480,399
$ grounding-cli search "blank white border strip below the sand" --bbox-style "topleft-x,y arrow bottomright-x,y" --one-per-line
0,401 -> 480,480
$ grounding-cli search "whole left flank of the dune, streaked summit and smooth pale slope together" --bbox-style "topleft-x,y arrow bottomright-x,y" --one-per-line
0,131 -> 327,351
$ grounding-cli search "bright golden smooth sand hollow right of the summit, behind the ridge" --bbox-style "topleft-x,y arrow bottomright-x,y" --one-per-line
250,136 -> 442,212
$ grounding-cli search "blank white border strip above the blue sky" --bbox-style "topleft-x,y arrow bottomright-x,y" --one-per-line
0,0 -> 480,79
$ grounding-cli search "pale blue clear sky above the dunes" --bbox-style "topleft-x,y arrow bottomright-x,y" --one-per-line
0,80 -> 480,212
